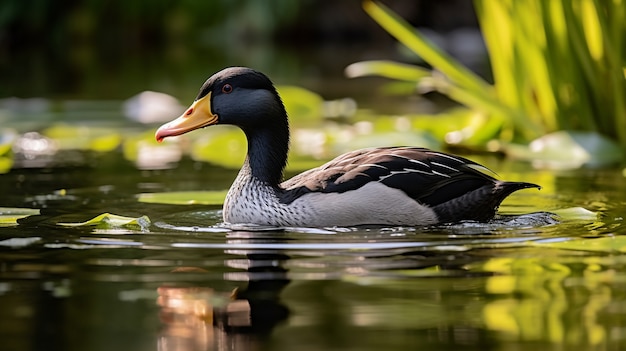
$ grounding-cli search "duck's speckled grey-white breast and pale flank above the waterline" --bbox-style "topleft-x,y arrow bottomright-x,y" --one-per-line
224,174 -> 437,227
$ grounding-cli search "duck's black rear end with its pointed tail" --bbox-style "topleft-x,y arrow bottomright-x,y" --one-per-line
433,181 -> 541,223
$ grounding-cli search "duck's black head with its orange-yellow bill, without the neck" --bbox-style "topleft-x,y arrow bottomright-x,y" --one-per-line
155,67 -> 288,141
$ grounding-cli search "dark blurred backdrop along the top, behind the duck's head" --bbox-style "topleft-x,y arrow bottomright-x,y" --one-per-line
0,0 -> 478,103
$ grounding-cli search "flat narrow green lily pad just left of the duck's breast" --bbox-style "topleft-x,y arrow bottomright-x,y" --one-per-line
138,190 -> 227,205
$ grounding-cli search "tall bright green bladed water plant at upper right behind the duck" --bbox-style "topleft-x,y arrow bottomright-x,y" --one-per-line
346,0 -> 626,162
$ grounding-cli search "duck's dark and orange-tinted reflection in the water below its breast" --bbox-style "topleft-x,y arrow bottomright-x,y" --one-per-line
157,232 -> 289,351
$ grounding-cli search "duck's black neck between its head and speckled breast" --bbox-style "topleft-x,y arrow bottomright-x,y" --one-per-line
242,122 -> 289,188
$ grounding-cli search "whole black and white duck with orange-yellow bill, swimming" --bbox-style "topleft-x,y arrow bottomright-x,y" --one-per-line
155,67 -> 540,227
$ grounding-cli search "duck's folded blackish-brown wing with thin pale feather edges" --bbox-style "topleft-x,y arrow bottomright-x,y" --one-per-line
279,147 -> 496,206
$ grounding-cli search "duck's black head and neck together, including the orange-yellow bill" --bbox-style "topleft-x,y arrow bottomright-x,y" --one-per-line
156,67 -> 289,186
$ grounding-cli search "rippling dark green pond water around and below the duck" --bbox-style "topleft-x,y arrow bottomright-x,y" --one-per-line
0,124 -> 626,350
